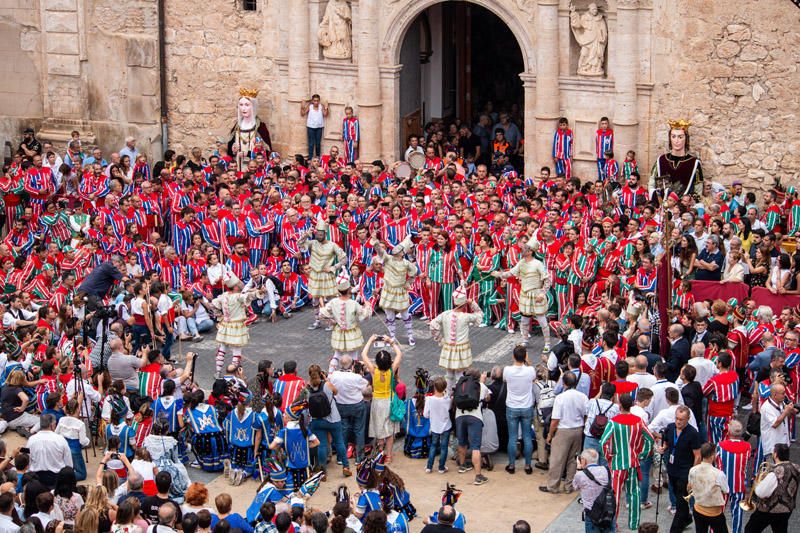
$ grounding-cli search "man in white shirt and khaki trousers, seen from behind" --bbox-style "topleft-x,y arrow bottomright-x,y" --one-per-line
539,372 -> 589,493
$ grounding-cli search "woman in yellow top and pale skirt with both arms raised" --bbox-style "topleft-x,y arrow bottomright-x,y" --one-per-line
361,335 -> 403,464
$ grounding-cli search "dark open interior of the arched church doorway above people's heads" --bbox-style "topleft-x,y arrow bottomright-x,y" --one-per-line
399,1 -> 525,149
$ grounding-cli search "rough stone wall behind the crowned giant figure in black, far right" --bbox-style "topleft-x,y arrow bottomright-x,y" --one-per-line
652,0 -> 800,189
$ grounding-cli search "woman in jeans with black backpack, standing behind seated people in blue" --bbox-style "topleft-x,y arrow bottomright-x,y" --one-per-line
307,365 -> 353,477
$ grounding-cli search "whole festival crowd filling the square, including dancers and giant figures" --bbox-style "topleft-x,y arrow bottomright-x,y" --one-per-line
0,102 -> 800,533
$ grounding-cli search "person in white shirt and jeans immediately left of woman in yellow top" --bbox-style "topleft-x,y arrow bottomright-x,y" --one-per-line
328,355 -> 369,463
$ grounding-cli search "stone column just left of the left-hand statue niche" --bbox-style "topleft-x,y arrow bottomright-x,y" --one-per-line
287,0 -> 311,154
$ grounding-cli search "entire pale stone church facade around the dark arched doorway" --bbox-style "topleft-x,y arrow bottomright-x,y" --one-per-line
0,0 -> 800,188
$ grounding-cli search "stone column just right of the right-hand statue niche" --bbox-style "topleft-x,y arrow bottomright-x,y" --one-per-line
611,0 -> 639,161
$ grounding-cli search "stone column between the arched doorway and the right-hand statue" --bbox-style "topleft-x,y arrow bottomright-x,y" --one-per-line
536,0 -> 561,170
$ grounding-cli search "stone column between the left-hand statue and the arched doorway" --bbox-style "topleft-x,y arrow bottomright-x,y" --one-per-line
356,0 -> 382,161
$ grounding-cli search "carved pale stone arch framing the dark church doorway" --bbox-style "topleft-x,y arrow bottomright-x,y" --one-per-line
380,0 -> 540,172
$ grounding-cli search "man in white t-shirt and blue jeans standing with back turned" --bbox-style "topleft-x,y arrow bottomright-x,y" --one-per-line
503,345 -> 536,475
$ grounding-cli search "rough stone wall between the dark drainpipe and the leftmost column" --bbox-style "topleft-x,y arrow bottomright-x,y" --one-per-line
166,0 -> 276,151
